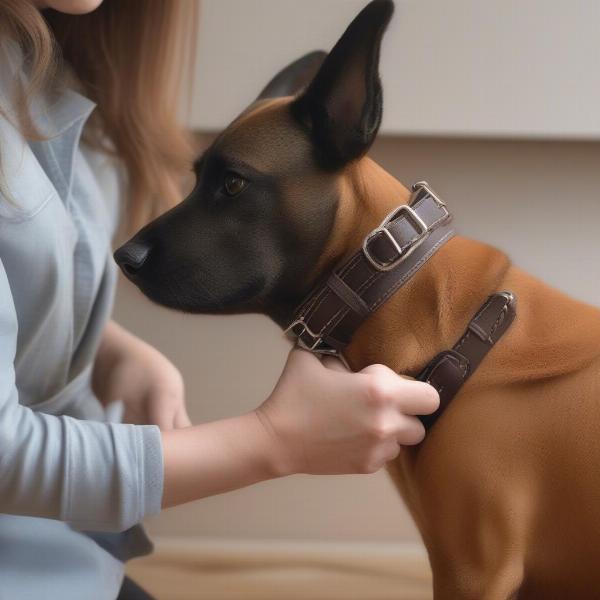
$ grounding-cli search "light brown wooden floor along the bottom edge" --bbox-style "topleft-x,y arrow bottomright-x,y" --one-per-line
128,541 -> 432,600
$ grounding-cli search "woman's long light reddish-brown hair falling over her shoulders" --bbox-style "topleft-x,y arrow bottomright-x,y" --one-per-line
0,0 -> 197,230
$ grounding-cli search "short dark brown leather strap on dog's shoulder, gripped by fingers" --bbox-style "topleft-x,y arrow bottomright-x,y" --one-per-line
415,292 -> 516,429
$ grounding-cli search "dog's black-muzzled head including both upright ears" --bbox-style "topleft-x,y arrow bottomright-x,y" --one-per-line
115,0 -> 393,324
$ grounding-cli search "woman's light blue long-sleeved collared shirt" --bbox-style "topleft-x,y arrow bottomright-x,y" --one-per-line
0,46 -> 163,600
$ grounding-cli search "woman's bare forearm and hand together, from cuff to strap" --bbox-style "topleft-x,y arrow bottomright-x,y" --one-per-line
162,350 -> 439,507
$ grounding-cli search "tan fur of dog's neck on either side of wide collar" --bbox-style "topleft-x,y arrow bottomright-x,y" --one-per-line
338,159 -> 510,374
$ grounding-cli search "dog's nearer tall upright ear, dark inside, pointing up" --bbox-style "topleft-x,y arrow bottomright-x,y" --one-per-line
291,0 -> 394,169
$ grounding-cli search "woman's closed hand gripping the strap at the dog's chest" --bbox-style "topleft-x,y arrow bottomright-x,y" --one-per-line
256,349 -> 439,474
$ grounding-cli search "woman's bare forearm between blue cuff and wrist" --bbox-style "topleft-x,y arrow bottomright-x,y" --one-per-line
162,412 -> 285,508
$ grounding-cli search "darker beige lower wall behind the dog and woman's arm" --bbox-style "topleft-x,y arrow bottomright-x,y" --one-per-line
116,138 -> 600,541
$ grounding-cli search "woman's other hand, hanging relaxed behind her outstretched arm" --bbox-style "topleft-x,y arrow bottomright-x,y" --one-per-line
92,321 -> 191,431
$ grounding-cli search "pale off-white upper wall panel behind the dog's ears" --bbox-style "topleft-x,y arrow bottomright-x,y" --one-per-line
192,0 -> 600,140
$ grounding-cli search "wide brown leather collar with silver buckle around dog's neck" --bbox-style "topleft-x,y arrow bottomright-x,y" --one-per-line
286,181 -> 454,355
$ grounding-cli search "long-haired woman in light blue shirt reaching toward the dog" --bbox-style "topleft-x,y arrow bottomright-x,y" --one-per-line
0,0 -> 438,600
